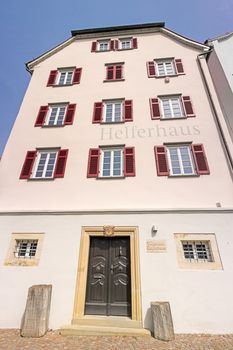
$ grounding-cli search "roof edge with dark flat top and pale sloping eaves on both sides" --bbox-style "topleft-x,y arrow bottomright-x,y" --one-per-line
26,22 -> 209,72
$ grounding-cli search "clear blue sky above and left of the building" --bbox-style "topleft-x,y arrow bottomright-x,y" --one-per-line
0,0 -> 233,155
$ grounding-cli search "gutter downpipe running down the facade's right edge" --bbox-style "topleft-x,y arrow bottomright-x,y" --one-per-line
197,50 -> 233,174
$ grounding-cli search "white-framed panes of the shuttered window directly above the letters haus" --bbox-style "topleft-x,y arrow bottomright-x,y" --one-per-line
160,95 -> 185,119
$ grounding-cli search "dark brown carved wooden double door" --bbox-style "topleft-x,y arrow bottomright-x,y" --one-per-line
85,237 -> 131,316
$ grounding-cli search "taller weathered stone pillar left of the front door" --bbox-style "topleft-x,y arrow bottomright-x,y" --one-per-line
20,284 -> 52,338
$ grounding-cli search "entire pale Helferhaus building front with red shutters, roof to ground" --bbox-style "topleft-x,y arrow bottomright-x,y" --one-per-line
0,23 -> 233,333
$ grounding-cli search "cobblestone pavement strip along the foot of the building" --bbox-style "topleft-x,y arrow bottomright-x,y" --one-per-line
0,329 -> 233,350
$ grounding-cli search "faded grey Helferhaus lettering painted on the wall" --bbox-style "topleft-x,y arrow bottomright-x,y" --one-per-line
100,125 -> 201,140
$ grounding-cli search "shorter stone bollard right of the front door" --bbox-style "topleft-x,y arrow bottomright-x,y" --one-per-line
151,301 -> 174,341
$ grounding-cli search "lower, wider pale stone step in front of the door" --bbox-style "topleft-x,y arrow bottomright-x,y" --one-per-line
60,324 -> 151,337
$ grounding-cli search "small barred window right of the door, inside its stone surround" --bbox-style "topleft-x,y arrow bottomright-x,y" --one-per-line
182,241 -> 213,262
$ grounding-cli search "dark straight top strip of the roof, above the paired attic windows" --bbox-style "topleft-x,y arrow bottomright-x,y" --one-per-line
71,22 -> 165,36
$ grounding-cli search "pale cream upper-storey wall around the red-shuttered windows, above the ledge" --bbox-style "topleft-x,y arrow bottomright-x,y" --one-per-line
0,33 -> 233,210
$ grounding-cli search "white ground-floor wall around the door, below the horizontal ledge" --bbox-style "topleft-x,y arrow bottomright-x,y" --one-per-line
0,212 -> 233,334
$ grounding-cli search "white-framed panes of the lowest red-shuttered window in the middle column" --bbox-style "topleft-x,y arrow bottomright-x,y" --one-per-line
100,147 -> 124,177
